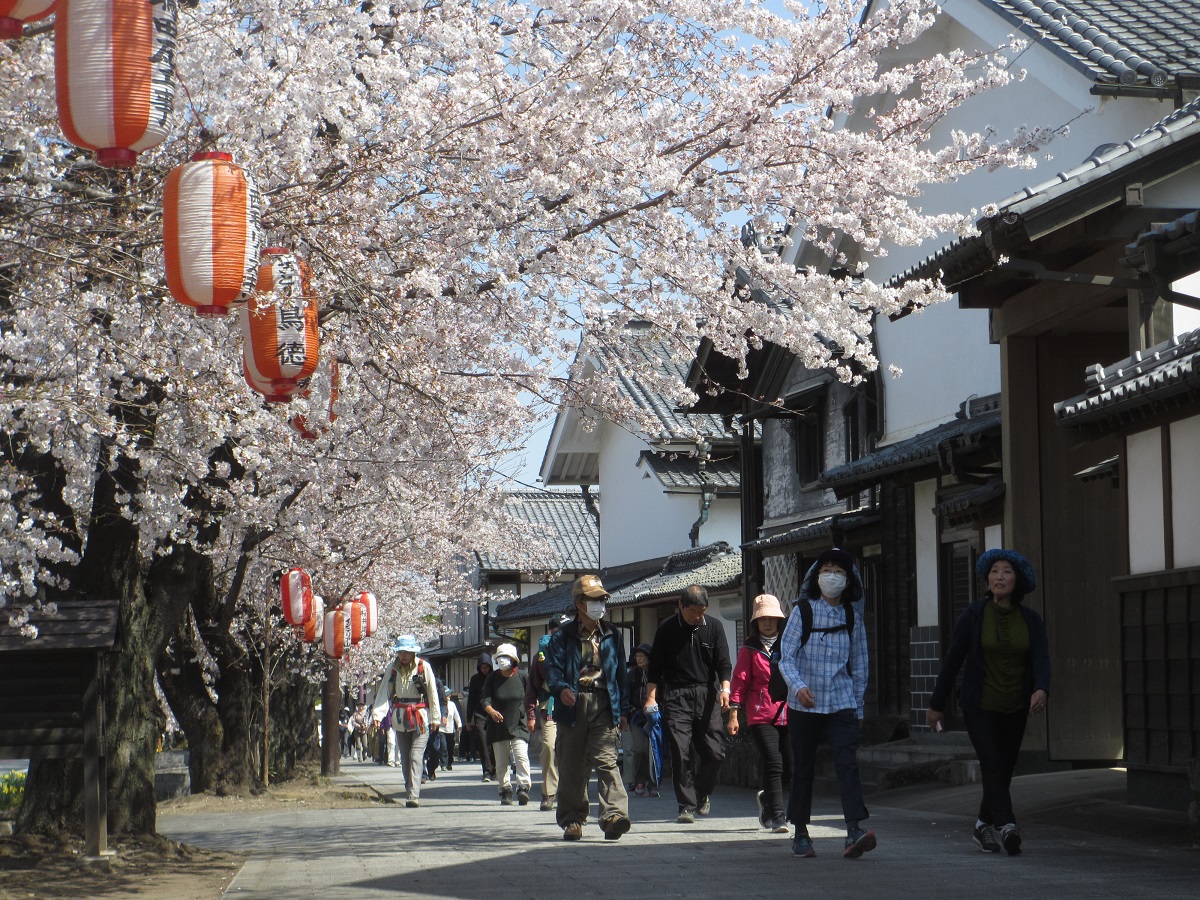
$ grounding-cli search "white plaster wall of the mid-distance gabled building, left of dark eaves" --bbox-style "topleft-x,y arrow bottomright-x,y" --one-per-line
600,422 -> 742,568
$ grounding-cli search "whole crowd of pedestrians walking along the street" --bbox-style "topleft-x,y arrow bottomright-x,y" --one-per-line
342,547 -> 1050,859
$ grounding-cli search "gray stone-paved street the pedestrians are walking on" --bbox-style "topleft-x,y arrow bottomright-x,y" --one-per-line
158,761 -> 1200,900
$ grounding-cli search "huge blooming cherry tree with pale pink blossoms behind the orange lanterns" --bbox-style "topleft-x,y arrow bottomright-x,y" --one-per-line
0,0 -> 1045,830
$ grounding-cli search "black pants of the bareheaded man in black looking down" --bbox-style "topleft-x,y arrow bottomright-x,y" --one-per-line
662,684 -> 725,809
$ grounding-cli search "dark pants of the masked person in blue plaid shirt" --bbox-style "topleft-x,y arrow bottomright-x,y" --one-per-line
787,708 -> 870,830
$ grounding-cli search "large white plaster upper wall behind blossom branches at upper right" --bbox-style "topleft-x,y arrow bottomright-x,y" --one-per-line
848,7 -> 1171,445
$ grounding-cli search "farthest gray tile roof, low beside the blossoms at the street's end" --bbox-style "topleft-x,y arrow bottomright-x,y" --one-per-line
479,491 -> 600,571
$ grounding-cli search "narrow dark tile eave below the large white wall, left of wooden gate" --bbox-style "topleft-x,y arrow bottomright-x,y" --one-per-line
820,394 -> 1001,492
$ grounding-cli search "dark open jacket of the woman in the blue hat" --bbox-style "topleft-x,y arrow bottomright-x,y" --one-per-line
929,596 -> 1050,713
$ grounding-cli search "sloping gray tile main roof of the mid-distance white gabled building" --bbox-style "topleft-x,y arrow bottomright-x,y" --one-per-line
587,322 -> 726,444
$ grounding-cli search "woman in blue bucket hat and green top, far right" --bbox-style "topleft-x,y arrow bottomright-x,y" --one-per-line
925,548 -> 1050,856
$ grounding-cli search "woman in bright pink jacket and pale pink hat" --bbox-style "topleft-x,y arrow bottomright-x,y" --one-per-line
728,594 -> 792,834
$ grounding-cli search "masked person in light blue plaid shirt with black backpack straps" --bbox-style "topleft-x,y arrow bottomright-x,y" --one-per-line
779,547 -> 875,859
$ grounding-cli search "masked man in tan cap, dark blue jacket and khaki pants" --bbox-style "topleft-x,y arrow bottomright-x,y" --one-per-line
545,575 -> 630,841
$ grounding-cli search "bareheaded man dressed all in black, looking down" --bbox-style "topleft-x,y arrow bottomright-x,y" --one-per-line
646,584 -> 733,824
